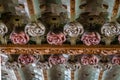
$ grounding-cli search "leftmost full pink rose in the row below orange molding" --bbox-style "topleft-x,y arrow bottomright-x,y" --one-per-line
18,54 -> 36,65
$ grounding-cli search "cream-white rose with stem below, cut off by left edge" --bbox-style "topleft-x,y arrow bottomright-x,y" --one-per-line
0,22 -> 8,44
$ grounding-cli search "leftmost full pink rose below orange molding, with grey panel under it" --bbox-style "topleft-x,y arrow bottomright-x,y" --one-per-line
18,54 -> 44,80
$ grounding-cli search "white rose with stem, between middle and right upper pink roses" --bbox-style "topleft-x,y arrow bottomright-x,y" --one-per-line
64,22 -> 84,45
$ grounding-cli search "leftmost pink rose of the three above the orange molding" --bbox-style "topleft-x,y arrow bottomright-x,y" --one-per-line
10,32 -> 29,44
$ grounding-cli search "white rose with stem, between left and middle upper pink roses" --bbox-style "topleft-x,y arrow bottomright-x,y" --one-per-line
25,22 -> 45,44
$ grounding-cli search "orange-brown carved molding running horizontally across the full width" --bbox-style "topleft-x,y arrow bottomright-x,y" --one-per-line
0,45 -> 120,55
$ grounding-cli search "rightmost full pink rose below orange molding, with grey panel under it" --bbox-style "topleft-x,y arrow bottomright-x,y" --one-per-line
75,56 -> 100,80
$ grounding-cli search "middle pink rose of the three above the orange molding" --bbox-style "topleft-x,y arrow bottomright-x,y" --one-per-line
47,32 -> 66,45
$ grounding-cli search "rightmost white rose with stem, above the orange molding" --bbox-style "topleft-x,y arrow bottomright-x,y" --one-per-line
101,22 -> 120,45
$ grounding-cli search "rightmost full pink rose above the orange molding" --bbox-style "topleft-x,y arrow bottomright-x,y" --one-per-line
81,32 -> 101,46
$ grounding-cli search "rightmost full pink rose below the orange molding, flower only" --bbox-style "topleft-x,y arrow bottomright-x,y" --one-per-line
81,55 -> 99,65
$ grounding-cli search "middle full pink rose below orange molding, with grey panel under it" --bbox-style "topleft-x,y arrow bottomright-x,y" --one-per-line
47,55 -> 71,80
